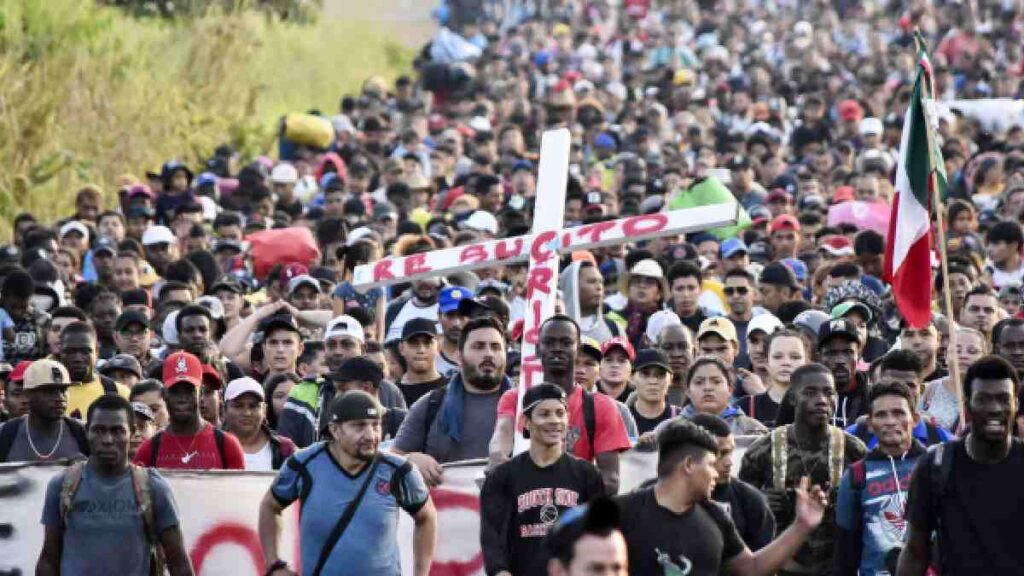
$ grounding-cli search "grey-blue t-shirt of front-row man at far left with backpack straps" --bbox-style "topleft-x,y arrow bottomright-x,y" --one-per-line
42,465 -> 178,576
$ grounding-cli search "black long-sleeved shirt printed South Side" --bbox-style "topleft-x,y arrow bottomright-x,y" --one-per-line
480,452 -> 604,576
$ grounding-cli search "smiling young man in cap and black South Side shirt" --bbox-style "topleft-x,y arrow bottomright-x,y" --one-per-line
480,383 -> 604,576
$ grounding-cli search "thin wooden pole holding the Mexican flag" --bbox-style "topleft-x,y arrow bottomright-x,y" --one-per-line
914,31 -> 967,434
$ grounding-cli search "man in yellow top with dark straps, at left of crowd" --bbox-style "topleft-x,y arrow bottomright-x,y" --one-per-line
58,322 -> 131,420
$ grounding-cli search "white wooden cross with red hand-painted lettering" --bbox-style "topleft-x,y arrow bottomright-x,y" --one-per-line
352,128 -> 739,438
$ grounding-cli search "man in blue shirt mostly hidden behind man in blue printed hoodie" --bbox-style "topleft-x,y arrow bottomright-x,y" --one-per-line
846,349 -> 953,450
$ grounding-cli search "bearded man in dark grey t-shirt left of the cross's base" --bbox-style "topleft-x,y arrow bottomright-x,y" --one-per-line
392,317 -> 512,486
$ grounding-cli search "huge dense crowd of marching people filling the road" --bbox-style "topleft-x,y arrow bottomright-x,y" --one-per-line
0,0 -> 1024,576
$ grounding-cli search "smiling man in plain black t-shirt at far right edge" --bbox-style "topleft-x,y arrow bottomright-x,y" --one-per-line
897,356 -> 1024,576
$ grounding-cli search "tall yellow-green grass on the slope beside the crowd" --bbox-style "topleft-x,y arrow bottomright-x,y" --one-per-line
0,0 -> 413,234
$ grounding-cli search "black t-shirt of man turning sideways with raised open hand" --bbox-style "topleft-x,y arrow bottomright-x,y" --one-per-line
616,486 -> 743,576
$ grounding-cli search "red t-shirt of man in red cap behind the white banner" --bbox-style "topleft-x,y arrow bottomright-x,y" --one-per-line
134,425 -> 246,470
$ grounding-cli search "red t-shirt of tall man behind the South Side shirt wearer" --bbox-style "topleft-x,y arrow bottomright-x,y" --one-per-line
498,386 -> 632,461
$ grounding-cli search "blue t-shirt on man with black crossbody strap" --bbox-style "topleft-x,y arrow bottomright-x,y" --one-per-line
270,442 -> 430,576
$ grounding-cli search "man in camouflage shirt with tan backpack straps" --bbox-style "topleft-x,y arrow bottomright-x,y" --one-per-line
739,364 -> 867,576
